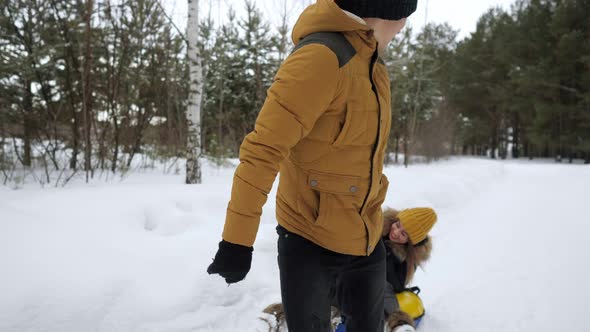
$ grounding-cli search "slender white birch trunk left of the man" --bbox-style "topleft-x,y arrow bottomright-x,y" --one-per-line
186,0 -> 203,184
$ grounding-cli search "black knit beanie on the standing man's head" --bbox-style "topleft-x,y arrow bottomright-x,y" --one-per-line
336,0 -> 418,21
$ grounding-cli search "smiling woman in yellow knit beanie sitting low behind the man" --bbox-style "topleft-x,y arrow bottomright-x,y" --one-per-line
382,208 -> 437,332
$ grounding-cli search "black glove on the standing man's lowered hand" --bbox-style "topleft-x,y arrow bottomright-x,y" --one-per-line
207,240 -> 254,284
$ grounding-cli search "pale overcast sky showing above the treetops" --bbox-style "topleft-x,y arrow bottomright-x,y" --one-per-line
161,0 -> 515,38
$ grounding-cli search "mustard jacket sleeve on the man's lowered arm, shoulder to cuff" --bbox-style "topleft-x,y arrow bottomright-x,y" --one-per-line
223,44 -> 339,247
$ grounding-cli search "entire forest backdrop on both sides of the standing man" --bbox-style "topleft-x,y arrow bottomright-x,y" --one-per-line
0,0 -> 590,187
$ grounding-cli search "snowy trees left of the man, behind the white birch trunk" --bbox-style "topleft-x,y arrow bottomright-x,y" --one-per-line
0,0 -> 287,184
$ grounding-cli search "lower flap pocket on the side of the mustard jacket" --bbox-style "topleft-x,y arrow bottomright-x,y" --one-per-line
298,170 -> 367,226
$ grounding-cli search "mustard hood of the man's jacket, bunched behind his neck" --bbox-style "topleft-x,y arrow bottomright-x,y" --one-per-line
291,0 -> 371,45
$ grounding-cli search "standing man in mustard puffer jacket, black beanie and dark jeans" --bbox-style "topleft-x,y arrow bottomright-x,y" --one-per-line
208,0 -> 416,332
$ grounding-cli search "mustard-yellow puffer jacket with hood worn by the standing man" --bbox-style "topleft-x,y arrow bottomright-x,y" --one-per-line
223,0 -> 391,256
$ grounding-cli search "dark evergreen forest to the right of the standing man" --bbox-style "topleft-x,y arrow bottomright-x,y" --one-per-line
388,0 -> 590,163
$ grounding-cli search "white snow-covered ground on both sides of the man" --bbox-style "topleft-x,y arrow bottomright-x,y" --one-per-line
0,159 -> 590,332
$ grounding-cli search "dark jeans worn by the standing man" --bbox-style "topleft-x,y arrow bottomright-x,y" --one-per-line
277,225 -> 385,332
